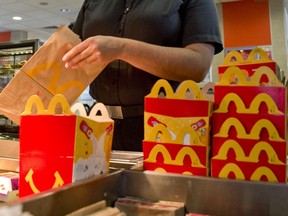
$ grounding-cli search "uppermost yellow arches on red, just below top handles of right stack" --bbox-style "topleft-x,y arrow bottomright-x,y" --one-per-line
214,93 -> 283,114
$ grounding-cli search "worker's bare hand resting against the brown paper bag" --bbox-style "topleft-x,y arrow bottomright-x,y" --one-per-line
62,36 -> 121,69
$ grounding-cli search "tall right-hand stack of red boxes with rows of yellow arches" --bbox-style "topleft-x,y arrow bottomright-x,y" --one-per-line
211,66 -> 287,183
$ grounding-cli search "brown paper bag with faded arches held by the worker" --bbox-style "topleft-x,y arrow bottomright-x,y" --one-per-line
0,25 -> 106,125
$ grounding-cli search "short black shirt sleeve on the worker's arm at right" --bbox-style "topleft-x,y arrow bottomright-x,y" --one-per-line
182,0 -> 223,54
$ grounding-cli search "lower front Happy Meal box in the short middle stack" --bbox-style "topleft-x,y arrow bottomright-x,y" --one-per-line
143,124 -> 209,176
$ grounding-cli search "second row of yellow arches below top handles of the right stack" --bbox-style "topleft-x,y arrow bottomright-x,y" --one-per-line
214,117 -> 284,141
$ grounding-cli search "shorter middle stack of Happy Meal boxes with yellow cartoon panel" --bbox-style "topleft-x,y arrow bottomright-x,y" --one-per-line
143,79 -> 213,176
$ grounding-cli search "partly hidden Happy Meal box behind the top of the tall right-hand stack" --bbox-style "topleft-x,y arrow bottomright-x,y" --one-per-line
218,47 -> 277,82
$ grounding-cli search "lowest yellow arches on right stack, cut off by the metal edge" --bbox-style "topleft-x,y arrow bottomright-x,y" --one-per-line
219,163 -> 278,182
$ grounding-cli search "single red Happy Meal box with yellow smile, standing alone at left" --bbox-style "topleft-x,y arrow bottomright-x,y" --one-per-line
19,95 -> 114,197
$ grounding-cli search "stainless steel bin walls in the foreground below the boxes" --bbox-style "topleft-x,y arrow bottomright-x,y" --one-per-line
2,170 -> 288,216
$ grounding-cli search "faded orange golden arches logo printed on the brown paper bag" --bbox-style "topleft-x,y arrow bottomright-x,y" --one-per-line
27,62 -> 85,94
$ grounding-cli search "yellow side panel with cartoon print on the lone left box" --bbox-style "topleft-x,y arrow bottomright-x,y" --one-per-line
73,104 -> 113,181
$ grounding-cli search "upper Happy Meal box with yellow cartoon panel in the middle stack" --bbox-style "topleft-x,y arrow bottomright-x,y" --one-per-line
144,79 -> 213,145
